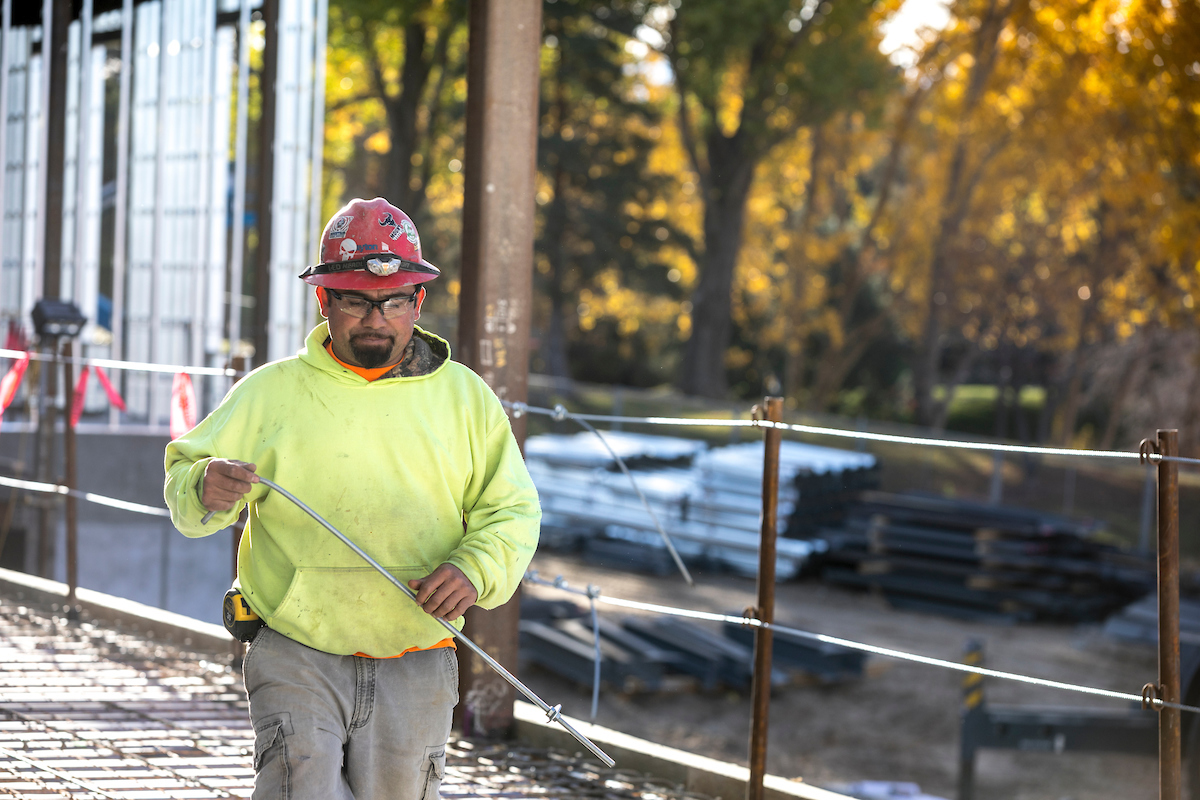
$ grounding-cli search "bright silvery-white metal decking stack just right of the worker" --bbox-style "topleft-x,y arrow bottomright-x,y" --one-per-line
526,432 -> 878,579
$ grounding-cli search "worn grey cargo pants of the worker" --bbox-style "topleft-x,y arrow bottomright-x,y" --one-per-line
242,627 -> 458,800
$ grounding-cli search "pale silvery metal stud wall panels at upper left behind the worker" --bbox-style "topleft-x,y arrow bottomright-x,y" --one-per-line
0,0 -> 328,426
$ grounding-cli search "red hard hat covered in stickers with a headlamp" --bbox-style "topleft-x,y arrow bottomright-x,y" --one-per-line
300,197 -> 442,289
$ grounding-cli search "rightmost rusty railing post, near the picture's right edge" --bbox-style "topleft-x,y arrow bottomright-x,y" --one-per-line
1158,429 -> 1183,800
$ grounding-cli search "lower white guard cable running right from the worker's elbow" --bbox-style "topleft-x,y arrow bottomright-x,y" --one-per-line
523,570 -> 1200,714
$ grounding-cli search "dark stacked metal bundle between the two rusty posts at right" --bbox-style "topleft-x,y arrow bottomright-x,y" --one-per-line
822,492 -> 1154,621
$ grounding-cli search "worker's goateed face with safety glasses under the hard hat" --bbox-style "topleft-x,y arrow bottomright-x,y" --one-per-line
317,285 -> 421,369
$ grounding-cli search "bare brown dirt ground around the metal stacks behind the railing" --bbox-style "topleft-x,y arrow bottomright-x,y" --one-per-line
522,552 -> 1158,800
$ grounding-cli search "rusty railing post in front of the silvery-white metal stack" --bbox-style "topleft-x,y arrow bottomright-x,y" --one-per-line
746,397 -> 784,800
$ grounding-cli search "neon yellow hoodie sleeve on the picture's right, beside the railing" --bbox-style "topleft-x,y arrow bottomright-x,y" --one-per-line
446,390 -> 541,608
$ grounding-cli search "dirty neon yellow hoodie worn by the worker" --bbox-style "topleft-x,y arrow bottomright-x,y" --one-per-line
164,323 -> 541,657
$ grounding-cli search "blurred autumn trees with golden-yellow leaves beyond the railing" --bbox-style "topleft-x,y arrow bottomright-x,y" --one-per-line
316,0 -> 1200,444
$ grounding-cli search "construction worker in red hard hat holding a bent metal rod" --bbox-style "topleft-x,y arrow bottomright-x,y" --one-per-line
166,198 -> 541,800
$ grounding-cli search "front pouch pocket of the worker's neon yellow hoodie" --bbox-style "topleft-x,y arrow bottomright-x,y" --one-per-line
266,566 -> 456,656
